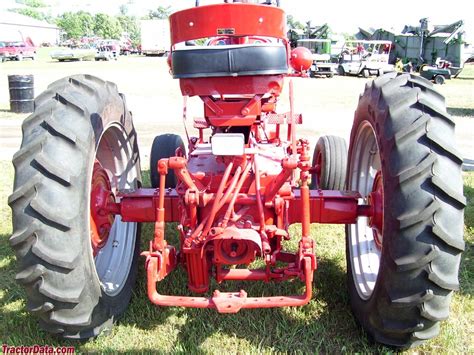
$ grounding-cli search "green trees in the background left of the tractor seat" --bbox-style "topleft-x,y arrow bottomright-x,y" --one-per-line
9,0 -> 171,46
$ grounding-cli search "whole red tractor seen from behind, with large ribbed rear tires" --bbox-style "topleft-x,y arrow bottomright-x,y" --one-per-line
9,3 -> 466,348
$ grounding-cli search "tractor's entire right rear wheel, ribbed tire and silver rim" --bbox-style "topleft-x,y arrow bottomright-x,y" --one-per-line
346,73 -> 466,348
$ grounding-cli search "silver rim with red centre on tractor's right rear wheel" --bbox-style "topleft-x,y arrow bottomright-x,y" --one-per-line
348,121 -> 383,300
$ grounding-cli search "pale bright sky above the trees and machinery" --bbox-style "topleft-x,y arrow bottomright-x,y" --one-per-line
0,0 -> 474,42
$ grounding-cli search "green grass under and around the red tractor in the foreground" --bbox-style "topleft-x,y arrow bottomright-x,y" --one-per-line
0,162 -> 474,353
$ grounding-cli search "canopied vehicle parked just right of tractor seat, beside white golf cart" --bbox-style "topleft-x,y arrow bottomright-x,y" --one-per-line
297,39 -> 337,78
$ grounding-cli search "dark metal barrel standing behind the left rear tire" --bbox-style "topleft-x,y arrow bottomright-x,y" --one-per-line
8,75 -> 35,113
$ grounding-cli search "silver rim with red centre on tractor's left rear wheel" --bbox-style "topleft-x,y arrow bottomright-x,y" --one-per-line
91,126 -> 138,297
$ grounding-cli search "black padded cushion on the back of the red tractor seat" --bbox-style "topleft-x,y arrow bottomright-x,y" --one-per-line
172,43 -> 288,79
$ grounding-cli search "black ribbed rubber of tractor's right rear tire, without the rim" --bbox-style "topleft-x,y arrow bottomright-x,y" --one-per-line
348,73 -> 466,348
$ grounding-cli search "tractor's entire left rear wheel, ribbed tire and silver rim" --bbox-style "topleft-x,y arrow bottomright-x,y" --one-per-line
8,75 -> 140,339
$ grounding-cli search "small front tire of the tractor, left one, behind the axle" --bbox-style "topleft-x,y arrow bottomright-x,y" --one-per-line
150,133 -> 186,188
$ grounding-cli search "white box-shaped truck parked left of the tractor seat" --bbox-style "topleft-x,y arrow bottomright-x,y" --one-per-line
140,20 -> 171,56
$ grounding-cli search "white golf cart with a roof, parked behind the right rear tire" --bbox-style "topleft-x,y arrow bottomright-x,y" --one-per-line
338,41 -> 395,78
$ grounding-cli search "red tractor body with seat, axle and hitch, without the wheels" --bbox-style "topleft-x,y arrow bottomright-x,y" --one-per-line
99,4 -> 370,313
